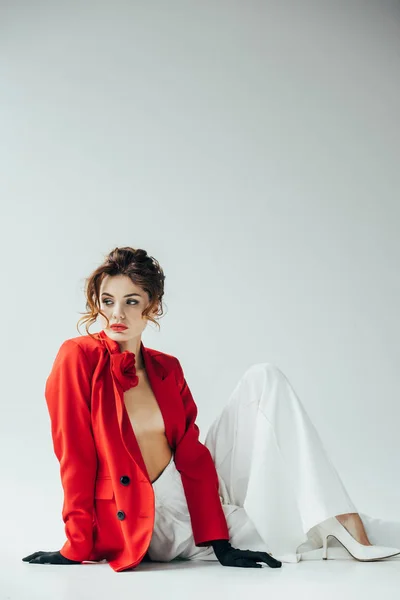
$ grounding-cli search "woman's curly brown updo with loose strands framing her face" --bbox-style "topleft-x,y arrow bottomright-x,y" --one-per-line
76,246 -> 165,337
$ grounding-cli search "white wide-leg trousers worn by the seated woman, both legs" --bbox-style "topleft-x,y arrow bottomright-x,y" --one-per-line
148,363 -> 400,562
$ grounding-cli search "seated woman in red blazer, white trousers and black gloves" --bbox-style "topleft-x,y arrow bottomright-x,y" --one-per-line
22,247 -> 400,572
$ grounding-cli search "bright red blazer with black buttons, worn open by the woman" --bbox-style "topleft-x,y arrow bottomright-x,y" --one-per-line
45,331 -> 229,571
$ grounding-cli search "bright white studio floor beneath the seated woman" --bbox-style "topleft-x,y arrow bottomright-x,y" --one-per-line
5,549 -> 400,600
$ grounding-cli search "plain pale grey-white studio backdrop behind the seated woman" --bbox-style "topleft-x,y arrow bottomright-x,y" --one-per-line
0,0 -> 400,557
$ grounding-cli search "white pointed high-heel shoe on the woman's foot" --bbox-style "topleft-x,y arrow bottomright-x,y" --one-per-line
316,517 -> 400,561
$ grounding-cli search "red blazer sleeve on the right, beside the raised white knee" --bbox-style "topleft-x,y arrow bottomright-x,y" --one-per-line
174,359 -> 229,547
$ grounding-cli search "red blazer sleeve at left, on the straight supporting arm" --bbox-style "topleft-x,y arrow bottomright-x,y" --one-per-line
45,340 -> 97,561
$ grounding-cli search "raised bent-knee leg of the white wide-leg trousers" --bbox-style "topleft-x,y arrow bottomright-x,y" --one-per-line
205,363 -> 366,562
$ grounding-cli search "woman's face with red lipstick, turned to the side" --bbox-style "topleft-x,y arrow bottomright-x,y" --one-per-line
99,275 -> 149,342
